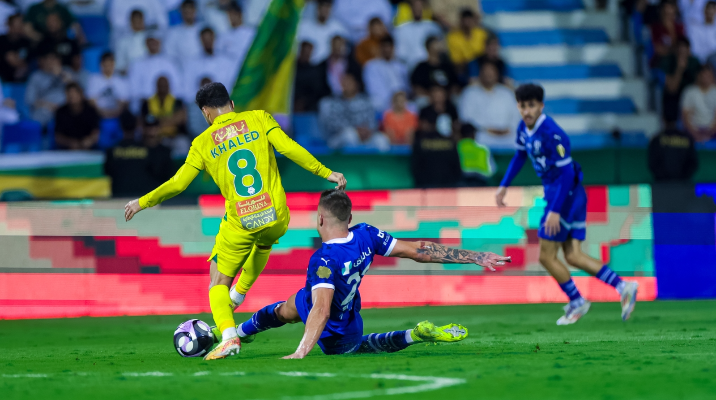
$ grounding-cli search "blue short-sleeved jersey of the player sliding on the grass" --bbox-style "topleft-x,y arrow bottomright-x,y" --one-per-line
297,224 -> 397,337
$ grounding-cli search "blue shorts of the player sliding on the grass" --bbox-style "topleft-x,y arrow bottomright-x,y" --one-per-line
296,288 -> 363,355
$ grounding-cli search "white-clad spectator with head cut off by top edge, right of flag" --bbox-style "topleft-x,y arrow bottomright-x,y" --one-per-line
333,0 -> 393,43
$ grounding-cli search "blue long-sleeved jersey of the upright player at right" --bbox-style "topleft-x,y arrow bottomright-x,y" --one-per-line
517,114 -> 581,189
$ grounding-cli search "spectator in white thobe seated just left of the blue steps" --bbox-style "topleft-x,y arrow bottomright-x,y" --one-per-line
458,61 -> 520,149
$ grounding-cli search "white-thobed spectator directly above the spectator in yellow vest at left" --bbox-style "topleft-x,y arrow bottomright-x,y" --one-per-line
129,32 -> 181,114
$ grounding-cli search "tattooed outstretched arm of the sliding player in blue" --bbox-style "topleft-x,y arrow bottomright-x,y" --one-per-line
390,240 -> 512,271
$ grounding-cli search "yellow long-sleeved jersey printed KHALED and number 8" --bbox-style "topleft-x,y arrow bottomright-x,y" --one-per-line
139,110 -> 332,231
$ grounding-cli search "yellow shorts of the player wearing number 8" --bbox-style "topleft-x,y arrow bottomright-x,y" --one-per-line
207,212 -> 291,277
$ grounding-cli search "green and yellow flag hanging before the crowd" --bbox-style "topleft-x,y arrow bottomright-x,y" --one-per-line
231,0 -> 304,115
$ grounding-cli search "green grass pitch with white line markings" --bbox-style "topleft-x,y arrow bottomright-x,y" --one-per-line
0,301 -> 716,400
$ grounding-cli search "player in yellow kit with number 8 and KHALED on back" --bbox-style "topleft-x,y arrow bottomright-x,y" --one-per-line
125,83 -> 346,360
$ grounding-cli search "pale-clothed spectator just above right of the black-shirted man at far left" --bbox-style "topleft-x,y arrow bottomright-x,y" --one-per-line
87,52 -> 129,118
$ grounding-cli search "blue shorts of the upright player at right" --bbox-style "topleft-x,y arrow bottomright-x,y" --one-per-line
537,183 -> 587,242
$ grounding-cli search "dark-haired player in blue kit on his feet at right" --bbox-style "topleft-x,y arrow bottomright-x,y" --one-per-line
495,84 -> 639,325
